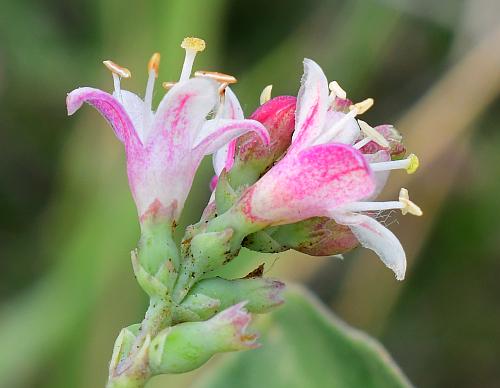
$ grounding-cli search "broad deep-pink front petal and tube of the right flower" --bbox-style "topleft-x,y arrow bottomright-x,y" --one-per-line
240,144 -> 375,225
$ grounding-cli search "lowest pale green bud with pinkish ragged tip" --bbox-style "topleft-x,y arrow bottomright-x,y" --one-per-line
149,302 -> 258,375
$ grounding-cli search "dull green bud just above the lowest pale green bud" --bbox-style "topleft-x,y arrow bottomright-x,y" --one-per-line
181,277 -> 285,319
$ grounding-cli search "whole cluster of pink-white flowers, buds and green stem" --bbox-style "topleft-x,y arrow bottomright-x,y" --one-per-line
67,38 -> 422,387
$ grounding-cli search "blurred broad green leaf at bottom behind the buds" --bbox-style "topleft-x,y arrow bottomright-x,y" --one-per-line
195,288 -> 411,388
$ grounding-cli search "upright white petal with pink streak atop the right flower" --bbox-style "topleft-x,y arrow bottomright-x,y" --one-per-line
290,58 -> 329,152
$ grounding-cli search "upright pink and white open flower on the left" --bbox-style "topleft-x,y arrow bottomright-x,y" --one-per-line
66,38 -> 269,222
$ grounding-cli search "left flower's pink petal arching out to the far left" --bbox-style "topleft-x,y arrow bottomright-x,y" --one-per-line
66,87 -> 141,146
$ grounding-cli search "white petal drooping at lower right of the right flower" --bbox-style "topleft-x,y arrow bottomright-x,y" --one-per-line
331,210 -> 406,280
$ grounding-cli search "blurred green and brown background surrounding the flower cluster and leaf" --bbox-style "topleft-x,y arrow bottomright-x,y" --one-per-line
0,0 -> 500,388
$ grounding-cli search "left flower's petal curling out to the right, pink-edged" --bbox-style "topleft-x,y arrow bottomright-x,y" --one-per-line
193,119 -> 270,155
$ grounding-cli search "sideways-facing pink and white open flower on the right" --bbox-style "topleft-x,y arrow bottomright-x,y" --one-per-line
237,59 -> 421,280
